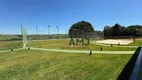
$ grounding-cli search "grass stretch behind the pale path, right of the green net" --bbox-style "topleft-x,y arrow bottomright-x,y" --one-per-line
27,39 -> 137,51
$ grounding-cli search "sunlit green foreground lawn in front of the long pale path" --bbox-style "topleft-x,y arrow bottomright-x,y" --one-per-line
0,50 -> 132,80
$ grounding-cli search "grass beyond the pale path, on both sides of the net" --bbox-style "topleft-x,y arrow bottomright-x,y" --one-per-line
0,39 -> 142,51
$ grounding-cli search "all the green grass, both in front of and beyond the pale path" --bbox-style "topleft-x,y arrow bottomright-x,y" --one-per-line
0,39 -> 142,80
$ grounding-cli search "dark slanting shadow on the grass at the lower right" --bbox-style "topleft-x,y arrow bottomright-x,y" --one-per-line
117,47 -> 141,80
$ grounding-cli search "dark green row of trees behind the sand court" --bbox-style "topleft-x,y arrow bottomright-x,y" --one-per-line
103,23 -> 142,37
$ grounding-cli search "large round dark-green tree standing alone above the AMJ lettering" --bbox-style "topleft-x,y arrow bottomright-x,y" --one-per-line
69,21 -> 94,38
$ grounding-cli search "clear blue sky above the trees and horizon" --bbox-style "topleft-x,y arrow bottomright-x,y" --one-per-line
0,0 -> 142,34
